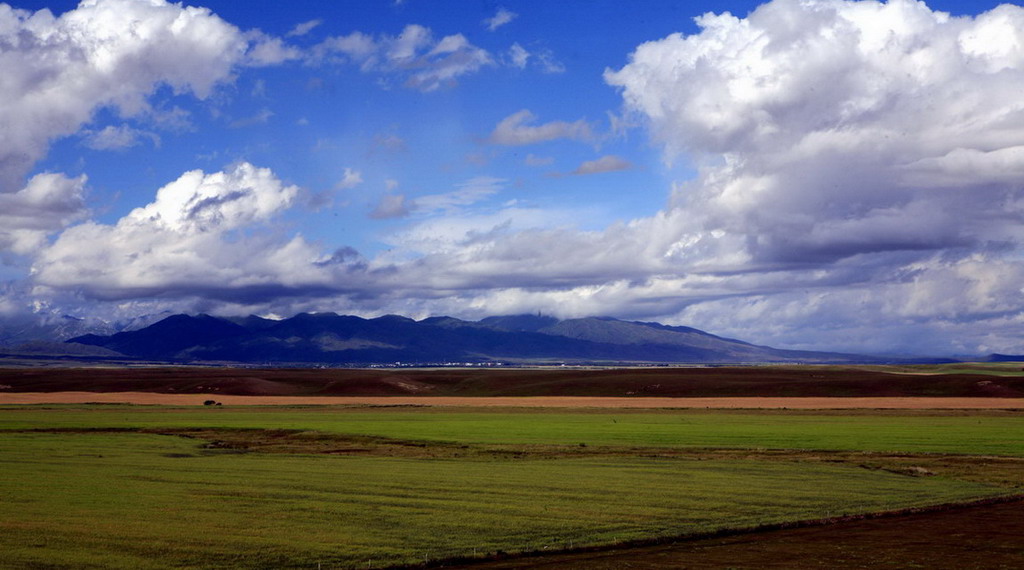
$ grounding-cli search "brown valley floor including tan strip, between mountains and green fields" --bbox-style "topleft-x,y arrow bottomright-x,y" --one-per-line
0,362 -> 1024,397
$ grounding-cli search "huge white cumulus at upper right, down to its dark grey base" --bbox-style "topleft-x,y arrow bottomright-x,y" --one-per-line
605,0 -> 1024,262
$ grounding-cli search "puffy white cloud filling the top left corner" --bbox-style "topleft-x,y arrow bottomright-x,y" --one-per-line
0,0 -> 249,191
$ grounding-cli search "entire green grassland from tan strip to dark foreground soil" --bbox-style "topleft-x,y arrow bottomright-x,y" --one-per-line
0,405 -> 1024,568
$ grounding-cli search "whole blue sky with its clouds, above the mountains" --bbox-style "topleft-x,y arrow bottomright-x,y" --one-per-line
0,0 -> 1024,354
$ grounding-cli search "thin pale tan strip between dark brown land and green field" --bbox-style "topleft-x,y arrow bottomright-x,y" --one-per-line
0,392 -> 1024,409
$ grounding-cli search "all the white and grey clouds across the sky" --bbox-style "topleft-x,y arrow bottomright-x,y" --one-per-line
0,0 -> 1024,353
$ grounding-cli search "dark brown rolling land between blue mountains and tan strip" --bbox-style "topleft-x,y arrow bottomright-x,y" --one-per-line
0,366 -> 1024,397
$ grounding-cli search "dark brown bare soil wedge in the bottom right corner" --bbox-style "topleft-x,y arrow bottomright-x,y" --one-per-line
449,500 -> 1024,570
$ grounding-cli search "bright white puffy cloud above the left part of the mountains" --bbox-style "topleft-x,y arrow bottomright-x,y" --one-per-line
32,163 -> 318,299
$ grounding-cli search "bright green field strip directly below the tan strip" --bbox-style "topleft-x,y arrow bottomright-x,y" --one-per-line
0,405 -> 1024,455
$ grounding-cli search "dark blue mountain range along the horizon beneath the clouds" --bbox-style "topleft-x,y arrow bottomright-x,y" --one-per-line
51,313 -> 909,365
